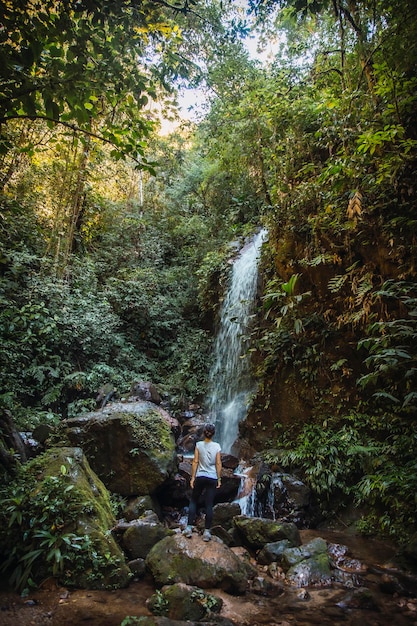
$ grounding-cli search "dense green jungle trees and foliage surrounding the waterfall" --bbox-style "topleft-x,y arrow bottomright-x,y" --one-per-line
0,0 -> 417,588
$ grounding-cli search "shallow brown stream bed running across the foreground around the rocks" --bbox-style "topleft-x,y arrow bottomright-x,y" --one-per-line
0,530 -> 417,626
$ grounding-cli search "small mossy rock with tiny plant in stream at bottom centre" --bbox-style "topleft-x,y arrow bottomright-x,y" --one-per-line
146,583 -> 223,621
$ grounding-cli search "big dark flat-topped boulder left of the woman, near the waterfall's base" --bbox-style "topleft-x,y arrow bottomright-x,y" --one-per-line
63,401 -> 176,496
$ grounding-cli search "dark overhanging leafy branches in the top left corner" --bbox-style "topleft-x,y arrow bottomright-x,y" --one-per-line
0,0 -> 185,167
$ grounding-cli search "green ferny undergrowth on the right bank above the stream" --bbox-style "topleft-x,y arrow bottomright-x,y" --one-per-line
266,412 -> 417,542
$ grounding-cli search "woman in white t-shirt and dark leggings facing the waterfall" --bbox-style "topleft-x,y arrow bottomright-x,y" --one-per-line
183,424 -> 222,541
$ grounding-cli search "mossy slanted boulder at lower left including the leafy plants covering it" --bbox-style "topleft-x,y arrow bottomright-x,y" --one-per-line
0,448 -> 129,589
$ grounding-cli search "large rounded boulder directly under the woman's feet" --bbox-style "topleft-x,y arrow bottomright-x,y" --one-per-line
146,534 -> 256,594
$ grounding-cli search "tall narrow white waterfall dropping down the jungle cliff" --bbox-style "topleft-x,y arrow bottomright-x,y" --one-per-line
209,230 -> 267,452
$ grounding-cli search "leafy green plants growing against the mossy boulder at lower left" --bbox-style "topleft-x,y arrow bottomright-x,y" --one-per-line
0,457 -> 115,592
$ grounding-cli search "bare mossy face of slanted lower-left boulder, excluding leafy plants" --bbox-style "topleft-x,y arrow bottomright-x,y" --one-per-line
5,447 -> 131,589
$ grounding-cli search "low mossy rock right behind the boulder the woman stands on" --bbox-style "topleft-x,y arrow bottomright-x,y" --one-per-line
234,515 -> 301,549
